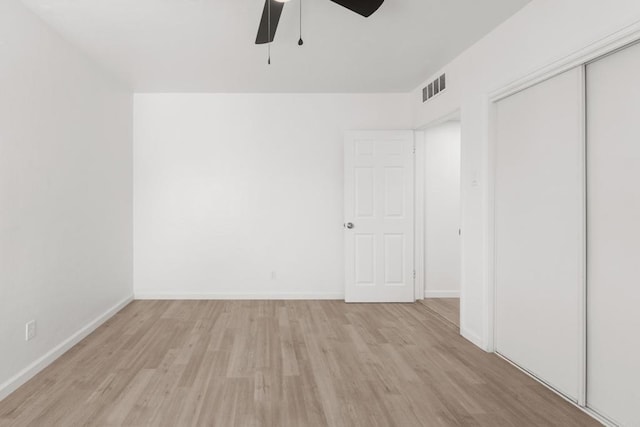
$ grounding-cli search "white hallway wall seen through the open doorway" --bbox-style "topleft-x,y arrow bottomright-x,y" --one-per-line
424,121 -> 460,298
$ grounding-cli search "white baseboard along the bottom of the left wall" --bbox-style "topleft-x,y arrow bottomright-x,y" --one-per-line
0,296 -> 133,400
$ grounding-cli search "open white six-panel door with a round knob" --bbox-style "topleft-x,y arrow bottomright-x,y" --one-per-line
344,131 -> 415,302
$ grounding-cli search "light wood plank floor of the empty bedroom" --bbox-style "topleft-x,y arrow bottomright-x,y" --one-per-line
0,301 -> 597,427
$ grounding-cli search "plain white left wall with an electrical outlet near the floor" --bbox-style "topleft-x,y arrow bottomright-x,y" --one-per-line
0,0 -> 132,398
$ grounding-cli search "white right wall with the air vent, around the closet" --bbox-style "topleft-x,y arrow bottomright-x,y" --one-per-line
412,0 -> 640,349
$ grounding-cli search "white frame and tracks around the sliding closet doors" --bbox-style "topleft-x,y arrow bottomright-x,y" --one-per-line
483,22 -> 640,425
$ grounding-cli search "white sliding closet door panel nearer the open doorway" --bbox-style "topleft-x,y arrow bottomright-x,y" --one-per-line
495,69 -> 584,401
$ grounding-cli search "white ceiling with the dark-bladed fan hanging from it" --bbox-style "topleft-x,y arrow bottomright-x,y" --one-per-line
23,0 -> 529,92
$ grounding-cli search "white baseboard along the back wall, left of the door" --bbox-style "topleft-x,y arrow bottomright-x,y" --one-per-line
134,292 -> 344,300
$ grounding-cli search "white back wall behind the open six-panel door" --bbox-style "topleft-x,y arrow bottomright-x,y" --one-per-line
134,94 -> 411,298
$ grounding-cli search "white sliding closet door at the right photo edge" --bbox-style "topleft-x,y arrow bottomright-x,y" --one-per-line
587,41 -> 640,426
